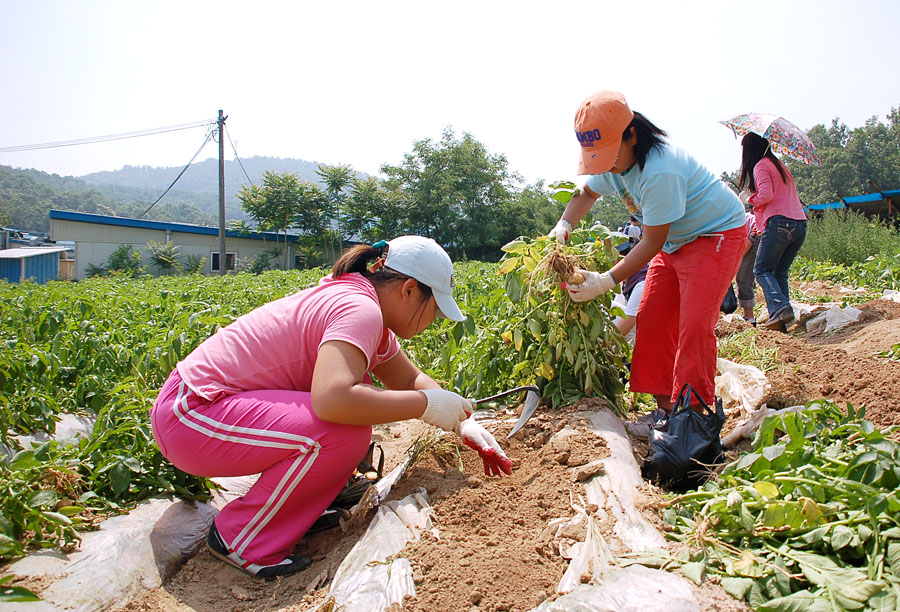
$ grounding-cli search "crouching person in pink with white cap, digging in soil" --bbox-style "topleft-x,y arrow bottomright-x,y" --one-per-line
150,236 -> 510,579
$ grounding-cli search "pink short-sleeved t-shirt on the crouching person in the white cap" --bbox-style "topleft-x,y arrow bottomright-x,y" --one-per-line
176,273 -> 400,400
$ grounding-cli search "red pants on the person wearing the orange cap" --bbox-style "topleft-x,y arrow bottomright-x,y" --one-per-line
630,226 -> 747,406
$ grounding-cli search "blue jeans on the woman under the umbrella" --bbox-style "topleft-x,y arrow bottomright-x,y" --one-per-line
753,215 -> 806,317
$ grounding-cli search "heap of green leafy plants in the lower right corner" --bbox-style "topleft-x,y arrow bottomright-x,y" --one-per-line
665,401 -> 900,611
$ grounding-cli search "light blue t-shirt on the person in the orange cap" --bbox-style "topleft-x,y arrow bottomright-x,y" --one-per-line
587,144 -> 747,253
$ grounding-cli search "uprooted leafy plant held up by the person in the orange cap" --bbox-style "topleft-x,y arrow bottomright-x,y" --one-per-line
499,225 -> 630,412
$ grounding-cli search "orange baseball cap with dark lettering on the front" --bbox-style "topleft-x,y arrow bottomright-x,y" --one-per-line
575,91 -> 634,174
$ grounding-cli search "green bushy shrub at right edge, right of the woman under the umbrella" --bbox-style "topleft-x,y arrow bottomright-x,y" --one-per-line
800,211 -> 900,266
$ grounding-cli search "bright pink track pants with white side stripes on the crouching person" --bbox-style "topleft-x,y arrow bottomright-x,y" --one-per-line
150,370 -> 372,565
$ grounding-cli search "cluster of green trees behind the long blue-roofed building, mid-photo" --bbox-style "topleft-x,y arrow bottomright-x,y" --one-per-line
234,128 -> 563,263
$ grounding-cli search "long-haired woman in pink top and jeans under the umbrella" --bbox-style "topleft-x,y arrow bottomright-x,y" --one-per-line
738,132 -> 806,331
